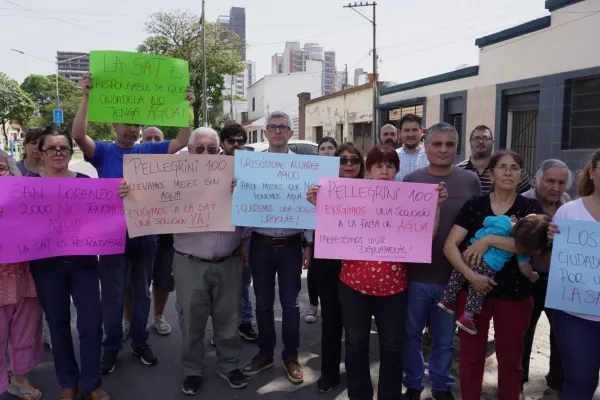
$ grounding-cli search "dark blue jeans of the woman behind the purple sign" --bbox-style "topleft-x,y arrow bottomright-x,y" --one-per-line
30,256 -> 102,393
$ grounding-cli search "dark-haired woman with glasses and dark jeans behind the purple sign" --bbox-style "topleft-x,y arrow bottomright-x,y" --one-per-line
30,127 -> 110,400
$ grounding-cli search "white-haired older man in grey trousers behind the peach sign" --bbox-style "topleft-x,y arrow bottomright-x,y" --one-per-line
173,128 -> 248,395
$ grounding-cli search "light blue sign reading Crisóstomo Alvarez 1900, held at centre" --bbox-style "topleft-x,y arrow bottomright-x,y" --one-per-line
231,151 -> 340,229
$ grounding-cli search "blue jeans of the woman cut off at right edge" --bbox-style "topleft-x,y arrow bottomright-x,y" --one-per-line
552,310 -> 600,400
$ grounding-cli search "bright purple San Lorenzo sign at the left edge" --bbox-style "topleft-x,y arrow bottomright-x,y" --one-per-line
0,177 -> 126,263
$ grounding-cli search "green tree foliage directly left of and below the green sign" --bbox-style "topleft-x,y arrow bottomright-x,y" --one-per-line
21,75 -> 113,140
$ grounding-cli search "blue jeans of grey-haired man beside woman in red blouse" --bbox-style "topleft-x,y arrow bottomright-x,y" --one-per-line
404,282 -> 455,392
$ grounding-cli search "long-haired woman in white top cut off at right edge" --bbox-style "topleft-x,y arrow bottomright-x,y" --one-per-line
548,150 -> 600,400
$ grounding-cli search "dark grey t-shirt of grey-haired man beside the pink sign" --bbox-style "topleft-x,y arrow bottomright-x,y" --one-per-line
404,168 -> 481,285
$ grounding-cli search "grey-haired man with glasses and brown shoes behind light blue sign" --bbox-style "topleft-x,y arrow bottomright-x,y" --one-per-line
242,111 -> 304,384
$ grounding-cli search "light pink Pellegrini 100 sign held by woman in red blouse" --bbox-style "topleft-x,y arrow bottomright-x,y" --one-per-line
314,178 -> 438,263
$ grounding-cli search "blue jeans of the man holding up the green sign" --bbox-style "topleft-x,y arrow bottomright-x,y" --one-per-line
100,235 -> 158,350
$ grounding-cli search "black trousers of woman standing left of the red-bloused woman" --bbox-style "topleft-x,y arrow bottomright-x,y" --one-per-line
308,258 -> 343,382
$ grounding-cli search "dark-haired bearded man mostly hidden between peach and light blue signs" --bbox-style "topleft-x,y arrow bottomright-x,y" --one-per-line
219,124 -> 258,342
